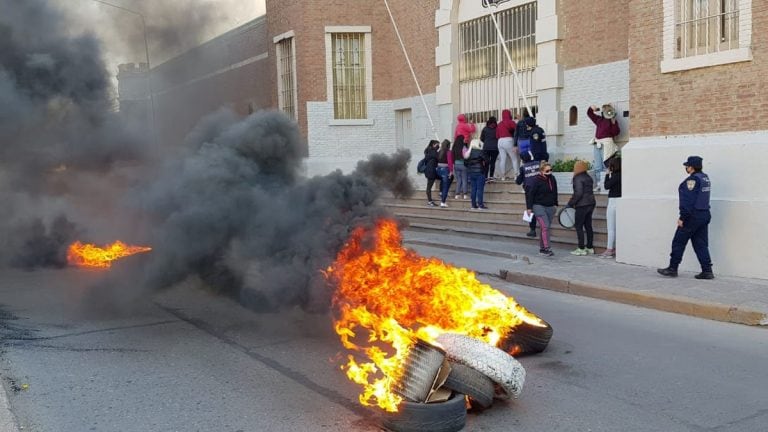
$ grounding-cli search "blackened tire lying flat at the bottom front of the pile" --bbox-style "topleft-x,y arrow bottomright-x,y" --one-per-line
382,393 -> 467,432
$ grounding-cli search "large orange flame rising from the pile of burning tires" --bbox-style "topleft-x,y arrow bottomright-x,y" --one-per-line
327,219 -> 541,412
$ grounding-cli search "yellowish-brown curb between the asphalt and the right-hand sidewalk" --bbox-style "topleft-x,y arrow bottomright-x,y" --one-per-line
499,270 -> 768,326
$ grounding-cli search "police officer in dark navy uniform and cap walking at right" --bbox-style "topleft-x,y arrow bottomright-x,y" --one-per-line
658,156 -> 715,279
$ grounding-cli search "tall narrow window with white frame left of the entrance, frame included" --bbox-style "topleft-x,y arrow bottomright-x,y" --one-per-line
326,27 -> 372,120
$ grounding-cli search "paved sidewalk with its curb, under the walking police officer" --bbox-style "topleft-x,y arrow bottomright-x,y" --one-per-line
403,230 -> 768,326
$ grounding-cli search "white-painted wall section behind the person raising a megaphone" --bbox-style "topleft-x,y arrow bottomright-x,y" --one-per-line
550,60 -> 629,160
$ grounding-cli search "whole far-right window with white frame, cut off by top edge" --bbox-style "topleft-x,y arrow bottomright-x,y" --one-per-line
661,0 -> 752,72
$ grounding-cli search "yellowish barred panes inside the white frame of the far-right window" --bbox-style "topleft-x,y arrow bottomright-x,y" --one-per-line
675,0 -> 739,58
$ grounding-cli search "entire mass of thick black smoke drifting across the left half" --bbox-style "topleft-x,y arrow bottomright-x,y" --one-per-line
0,0 -> 413,310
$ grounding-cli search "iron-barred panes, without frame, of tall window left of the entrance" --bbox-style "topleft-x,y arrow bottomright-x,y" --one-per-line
331,33 -> 368,119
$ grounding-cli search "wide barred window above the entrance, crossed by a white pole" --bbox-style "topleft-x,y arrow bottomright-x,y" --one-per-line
459,2 -> 538,82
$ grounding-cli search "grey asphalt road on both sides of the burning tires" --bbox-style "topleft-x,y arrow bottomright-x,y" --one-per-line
0,270 -> 768,432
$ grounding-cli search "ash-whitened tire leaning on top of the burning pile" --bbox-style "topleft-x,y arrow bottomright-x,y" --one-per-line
437,333 -> 525,399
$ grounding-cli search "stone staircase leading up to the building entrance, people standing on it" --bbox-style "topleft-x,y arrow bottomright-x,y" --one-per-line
381,181 -> 608,250
